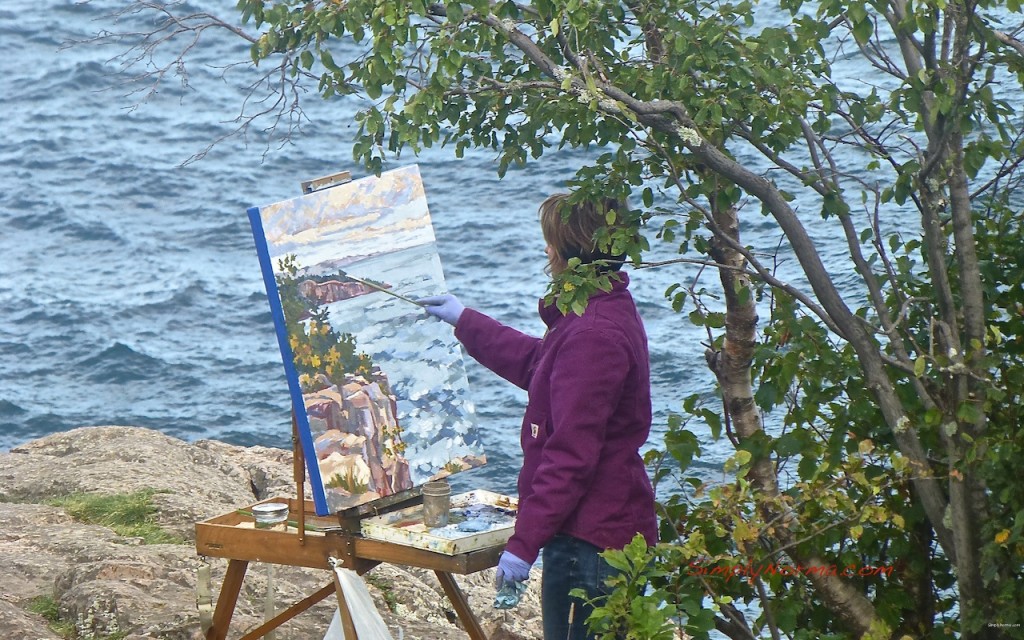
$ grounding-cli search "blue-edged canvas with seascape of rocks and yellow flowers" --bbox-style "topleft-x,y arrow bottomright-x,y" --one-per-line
249,165 -> 485,515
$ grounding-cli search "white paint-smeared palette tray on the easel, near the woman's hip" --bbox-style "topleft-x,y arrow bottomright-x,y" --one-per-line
361,489 -> 519,555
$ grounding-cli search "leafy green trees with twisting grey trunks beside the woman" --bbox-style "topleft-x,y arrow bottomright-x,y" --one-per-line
101,0 -> 1024,639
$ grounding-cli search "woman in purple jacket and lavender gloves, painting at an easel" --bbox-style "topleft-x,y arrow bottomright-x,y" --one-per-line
420,194 -> 657,640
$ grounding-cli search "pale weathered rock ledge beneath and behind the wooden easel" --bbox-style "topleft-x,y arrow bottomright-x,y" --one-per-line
0,426 -> 543,640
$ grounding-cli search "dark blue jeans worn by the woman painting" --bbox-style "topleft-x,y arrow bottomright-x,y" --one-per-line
541,536 -> 617,640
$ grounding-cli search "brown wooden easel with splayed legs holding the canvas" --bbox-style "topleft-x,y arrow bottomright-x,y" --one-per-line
196,171 -> 504,640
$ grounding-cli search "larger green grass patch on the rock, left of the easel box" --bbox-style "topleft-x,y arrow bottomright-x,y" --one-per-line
46,488 -> 187,545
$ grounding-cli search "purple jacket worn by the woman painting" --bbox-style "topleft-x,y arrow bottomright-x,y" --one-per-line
455,272 -> 657,563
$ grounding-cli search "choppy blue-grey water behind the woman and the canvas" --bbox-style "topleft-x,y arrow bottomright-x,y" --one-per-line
0,0 -> 757,490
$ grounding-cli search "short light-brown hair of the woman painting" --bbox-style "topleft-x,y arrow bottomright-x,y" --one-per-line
540,189 -> 629,271
